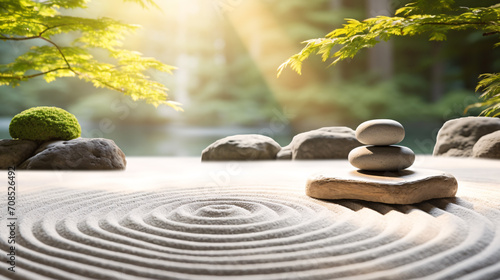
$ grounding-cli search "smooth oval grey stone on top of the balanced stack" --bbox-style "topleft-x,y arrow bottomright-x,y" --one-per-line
356,119 -> 405,145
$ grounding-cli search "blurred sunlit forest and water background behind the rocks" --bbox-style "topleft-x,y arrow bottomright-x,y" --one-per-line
0,0 -> 500,156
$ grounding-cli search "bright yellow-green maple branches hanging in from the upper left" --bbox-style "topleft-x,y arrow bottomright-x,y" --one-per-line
0,0 -> 180,110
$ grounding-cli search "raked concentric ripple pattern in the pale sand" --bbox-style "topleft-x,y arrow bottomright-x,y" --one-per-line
0,182 -> 500,279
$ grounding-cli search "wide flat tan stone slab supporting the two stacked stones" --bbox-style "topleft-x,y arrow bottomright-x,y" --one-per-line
306,169 -> 458,204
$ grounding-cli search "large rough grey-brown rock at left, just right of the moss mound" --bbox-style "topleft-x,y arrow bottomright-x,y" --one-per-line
19,138 -> 127,170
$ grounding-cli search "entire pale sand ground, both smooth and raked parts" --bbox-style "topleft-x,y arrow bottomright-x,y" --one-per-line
0,156 -> 500,279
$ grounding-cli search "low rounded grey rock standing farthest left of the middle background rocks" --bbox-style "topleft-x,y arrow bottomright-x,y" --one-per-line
201,134 -> 281,161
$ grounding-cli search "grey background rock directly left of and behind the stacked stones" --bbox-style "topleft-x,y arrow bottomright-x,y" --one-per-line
290,126 -> 361,159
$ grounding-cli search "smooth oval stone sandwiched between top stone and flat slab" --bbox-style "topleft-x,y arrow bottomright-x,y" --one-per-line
349,146 -> 415,171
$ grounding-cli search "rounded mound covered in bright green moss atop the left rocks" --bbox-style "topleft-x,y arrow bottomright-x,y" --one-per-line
9,107 -> 82,141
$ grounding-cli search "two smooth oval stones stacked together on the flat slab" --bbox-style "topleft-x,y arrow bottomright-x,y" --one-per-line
348,119 -> 415,171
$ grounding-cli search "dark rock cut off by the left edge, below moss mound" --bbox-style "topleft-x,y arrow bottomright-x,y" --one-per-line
0,139 -> 38,169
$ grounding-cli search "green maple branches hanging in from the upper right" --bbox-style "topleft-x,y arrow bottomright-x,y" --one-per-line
278,0 -> 500,117
